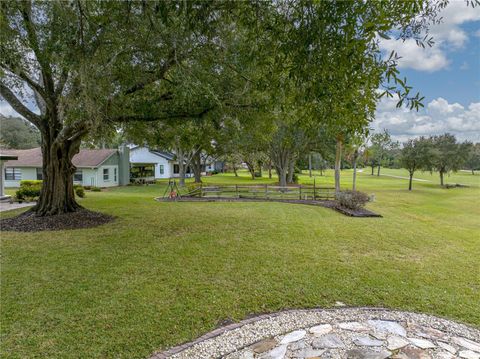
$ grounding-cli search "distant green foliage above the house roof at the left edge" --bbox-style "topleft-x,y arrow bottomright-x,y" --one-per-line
0,115 -> 40,149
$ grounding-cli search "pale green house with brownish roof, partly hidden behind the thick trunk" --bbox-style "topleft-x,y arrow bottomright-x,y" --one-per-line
2,147 -> 130,187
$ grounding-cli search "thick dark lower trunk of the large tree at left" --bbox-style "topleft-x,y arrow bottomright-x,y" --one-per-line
32,139 -> 82,216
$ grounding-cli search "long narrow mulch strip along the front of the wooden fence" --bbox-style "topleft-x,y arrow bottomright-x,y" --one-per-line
156,196 -> 382,217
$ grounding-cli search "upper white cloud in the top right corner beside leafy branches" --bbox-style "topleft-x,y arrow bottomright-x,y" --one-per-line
380,1 -> 480,72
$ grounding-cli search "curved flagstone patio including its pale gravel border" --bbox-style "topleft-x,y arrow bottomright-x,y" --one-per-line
151,308 -> 480,359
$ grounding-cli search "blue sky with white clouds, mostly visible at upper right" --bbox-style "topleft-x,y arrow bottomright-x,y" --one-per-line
0,0 -> 480,142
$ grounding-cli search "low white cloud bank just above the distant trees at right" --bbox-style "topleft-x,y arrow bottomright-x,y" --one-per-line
372,97 -> 480,142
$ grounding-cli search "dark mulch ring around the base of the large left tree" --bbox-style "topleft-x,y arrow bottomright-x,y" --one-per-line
0,209 -> 115,232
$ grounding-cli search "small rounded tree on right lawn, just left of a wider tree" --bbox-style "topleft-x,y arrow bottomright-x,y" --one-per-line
399,137 -> 432,191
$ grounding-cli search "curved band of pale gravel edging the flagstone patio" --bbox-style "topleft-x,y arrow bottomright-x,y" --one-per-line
150,307 -> 480,359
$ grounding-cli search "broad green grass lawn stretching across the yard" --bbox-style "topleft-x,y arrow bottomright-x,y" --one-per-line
0,169 -> 480,358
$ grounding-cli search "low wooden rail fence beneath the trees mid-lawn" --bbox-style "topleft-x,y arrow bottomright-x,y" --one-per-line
185,184 -> 335,200
